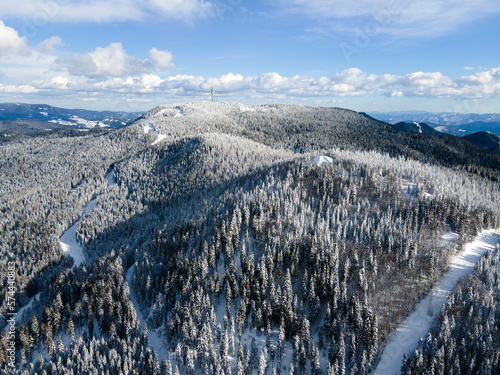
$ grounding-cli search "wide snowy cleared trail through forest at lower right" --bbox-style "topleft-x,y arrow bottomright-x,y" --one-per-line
374,229 -> 500,375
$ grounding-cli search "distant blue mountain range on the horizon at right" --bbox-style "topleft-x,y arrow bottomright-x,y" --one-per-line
368,111 -> 500,136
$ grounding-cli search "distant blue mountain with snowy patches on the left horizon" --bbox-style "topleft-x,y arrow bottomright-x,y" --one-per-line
0,103 -> 140,128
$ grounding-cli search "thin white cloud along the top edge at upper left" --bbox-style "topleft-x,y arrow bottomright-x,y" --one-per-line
0,0 -> 213,22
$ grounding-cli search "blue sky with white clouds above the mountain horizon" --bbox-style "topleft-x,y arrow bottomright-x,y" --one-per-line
0,0 -> 500,113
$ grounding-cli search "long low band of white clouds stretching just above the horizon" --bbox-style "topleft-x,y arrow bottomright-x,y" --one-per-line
26,68 -> 500,100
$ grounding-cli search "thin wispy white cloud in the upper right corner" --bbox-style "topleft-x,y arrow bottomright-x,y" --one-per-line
281,0 -> 500,38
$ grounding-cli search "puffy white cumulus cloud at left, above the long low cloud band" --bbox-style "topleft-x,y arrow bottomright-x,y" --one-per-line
56,43 -> 175,78
